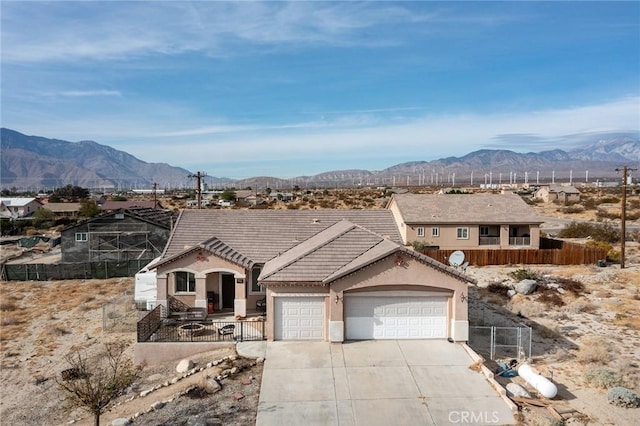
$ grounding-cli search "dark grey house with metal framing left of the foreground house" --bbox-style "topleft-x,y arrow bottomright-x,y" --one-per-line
61,208 -> 174,263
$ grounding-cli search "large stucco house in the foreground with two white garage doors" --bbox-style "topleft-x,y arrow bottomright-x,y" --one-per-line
155,210 -> 475,342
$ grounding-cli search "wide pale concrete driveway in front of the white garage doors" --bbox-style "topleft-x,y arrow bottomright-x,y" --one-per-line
256,340 -> 515,426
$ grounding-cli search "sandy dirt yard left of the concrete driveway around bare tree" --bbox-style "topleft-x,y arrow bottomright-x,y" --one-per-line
0,278 -> 262,426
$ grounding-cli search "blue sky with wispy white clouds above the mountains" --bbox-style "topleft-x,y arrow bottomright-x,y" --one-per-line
0,1 -> 640,178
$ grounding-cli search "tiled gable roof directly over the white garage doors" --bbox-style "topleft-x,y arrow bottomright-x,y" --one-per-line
258,221 -> 474,285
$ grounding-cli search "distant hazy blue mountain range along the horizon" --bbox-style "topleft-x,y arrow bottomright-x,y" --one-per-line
0,128 -> 640,190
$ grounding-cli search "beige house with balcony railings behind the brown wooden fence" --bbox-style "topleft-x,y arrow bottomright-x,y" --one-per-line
387,193 -> 544,250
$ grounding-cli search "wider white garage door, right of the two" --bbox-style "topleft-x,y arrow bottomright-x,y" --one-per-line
345,295 -> 447,340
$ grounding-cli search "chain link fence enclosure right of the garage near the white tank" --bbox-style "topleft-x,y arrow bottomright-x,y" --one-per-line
469,326 -> 533,360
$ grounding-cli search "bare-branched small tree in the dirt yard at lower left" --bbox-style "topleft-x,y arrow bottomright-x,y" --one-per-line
56,342 -> 142,426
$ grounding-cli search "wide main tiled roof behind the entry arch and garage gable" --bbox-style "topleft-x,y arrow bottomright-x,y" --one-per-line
163,209 -> 401,263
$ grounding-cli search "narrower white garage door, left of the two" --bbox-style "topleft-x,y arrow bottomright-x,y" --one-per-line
275,297 -> 325,340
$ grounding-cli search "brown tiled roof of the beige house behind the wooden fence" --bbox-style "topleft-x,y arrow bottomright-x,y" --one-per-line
393,193 -> 544,225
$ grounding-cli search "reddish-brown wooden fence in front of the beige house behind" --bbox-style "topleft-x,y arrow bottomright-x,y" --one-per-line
422,238 -> 607,266
